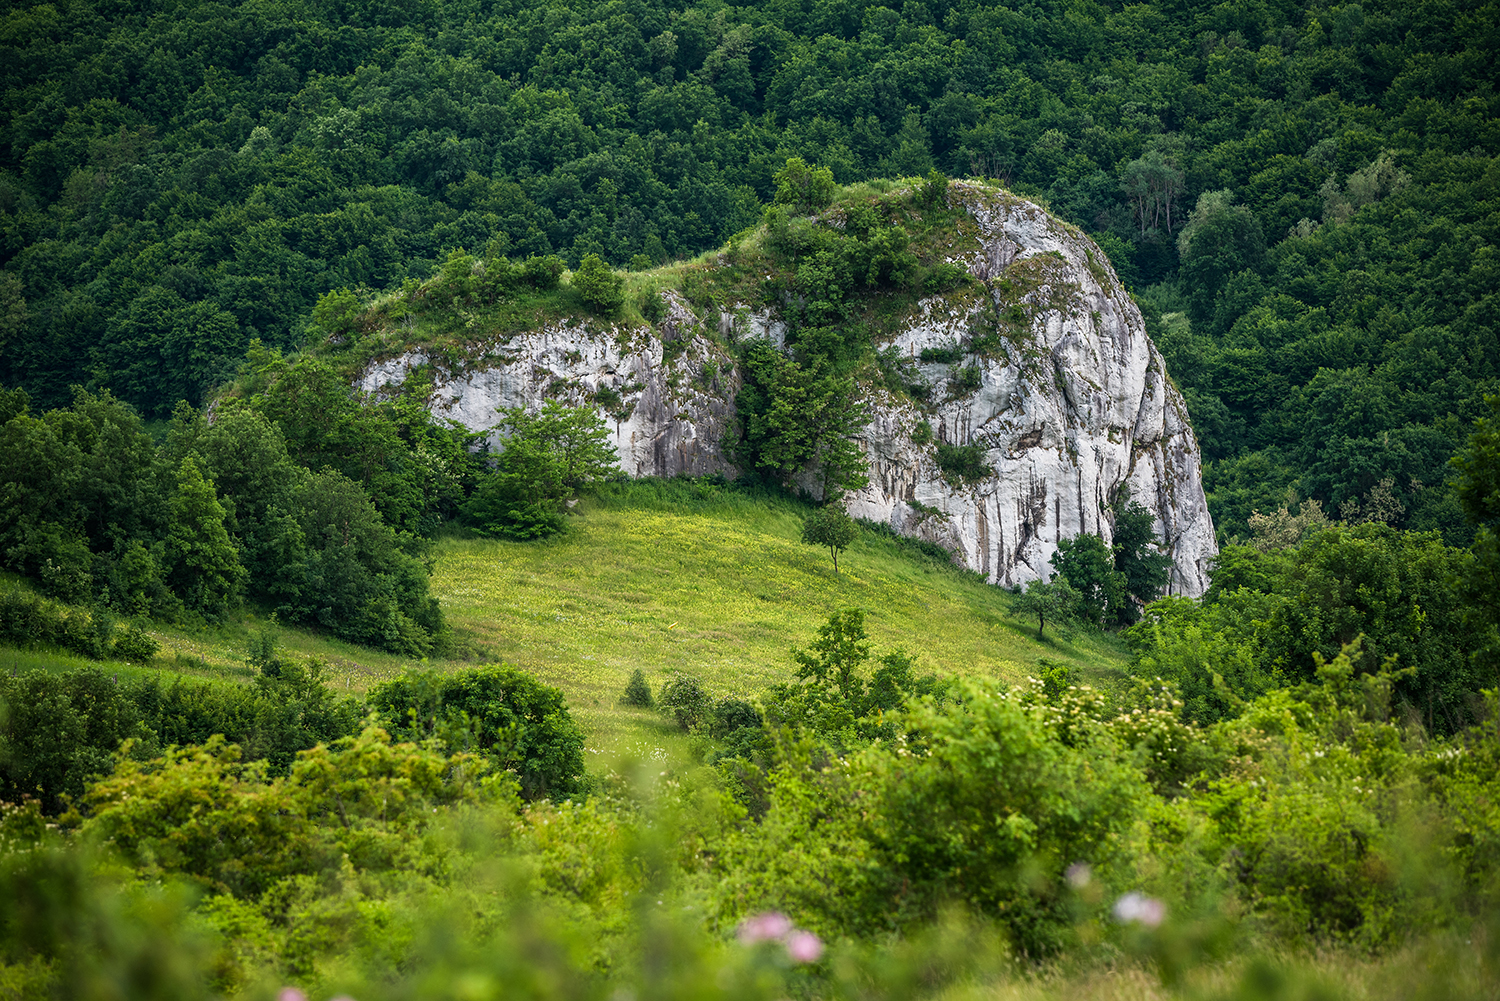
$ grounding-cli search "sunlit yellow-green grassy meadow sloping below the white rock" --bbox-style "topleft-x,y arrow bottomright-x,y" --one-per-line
0,480 -> 1127,758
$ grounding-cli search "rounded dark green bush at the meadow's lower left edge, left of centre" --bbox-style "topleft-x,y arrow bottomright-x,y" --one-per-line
369,665 -> 585,800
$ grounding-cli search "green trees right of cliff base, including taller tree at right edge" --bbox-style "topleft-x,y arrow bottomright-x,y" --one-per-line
1127,396 -> 1500,734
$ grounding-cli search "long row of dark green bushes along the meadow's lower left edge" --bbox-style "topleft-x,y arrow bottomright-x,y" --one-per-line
0,654 -> 588,816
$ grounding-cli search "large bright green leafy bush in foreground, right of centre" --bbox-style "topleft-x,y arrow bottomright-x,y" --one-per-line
725,672 -> 1149,956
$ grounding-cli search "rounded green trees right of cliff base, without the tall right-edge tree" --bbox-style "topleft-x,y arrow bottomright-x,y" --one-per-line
1128,524 -> 1496,734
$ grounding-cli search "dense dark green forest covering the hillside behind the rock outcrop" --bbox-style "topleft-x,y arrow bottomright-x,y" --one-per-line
0,0 -> 1500,543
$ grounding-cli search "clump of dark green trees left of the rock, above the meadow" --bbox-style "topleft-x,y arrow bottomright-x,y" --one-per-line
0,354 -> 483,656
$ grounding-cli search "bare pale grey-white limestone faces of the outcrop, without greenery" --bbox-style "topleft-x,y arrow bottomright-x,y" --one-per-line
360,183 -> 1217,596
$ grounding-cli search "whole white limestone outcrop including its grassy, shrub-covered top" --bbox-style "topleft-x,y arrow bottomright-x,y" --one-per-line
348,182 -> 1217,594
